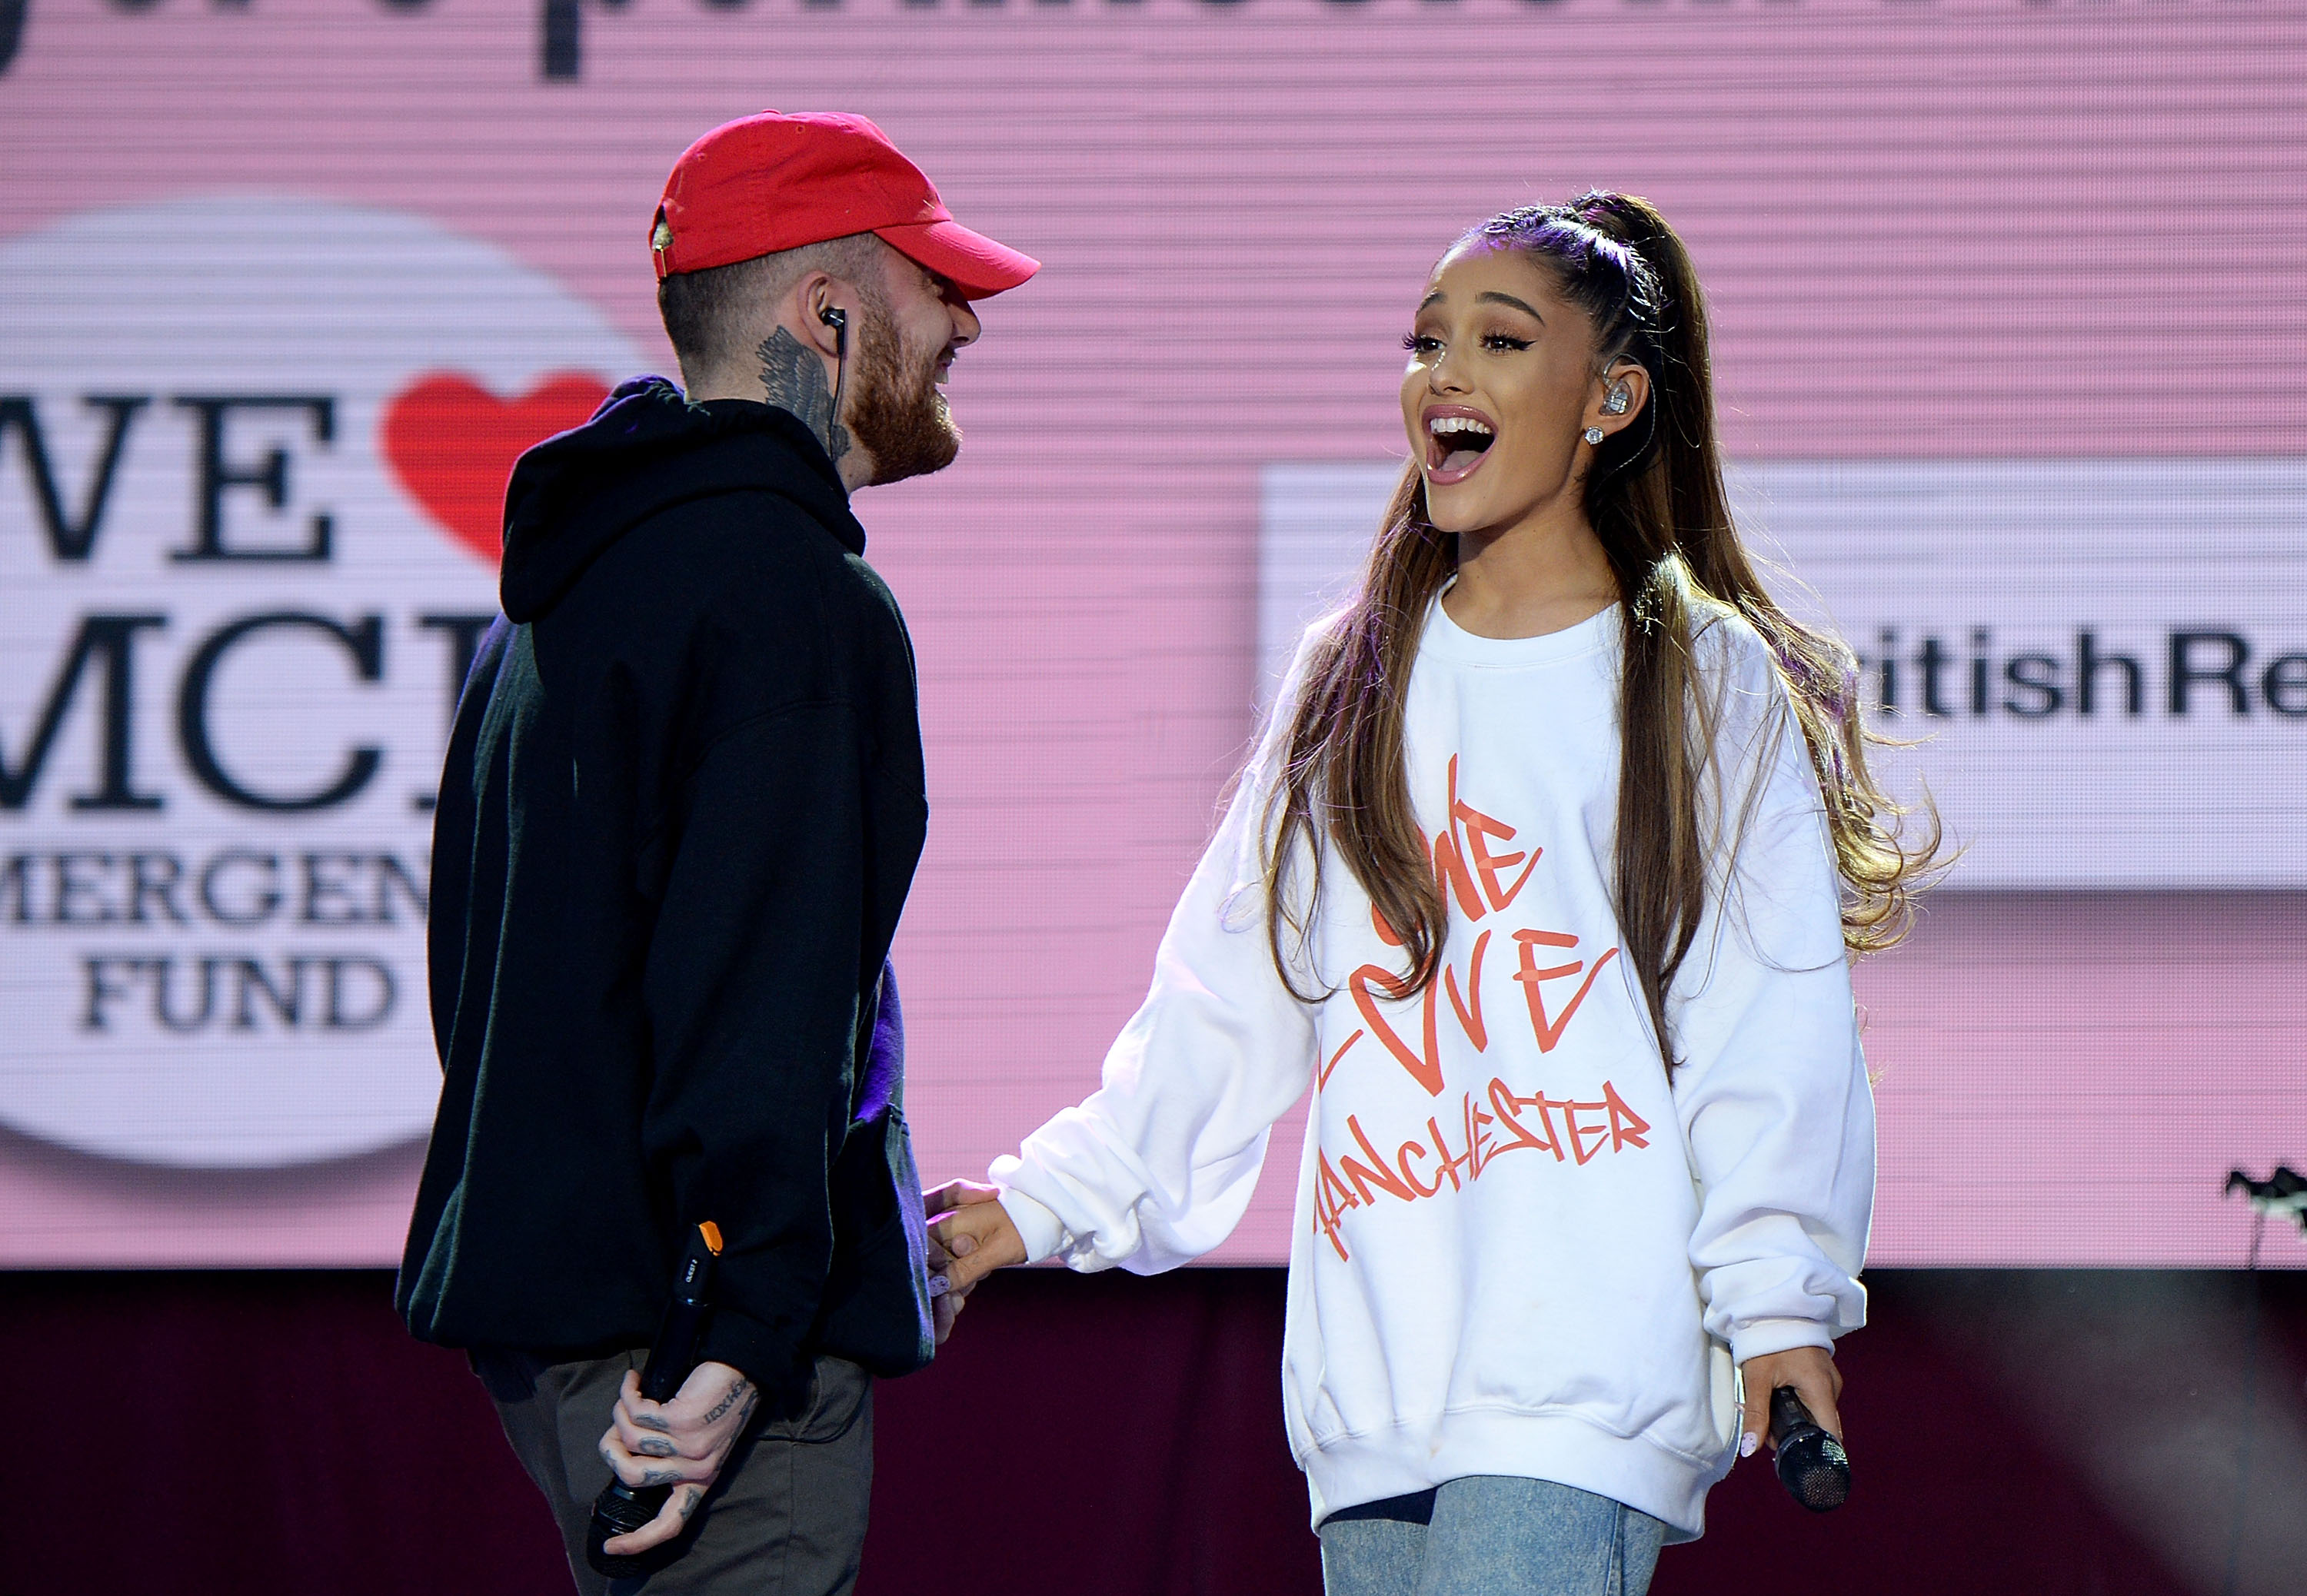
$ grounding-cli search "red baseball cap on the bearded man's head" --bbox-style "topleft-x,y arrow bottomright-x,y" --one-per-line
648,111 -> 1040,300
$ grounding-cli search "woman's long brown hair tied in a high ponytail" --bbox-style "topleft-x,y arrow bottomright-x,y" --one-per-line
1267,191 -> 1940,1070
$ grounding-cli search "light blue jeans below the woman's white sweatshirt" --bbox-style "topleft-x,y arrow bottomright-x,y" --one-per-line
1322,1474 -> 1666,1596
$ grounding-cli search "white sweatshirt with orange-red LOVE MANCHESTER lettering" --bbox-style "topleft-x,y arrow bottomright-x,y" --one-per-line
992,604 -> 1873,1538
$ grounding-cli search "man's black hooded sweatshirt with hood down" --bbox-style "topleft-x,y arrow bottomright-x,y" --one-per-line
399,378 -> 932,1393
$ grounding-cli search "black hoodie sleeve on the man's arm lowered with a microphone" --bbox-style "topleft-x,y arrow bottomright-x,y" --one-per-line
644,701 -> 865,1395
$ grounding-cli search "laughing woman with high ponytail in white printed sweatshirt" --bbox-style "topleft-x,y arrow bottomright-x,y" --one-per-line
932,194 -> 1936,1596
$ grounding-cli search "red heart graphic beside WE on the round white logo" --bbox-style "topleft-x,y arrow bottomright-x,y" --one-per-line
383,371 -> 609,565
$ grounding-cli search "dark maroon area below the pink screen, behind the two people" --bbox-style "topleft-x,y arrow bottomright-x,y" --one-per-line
0,1264 -> 2307,1596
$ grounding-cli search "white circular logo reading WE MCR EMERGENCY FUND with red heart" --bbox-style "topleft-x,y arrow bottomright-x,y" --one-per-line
0,194 -> 639,1167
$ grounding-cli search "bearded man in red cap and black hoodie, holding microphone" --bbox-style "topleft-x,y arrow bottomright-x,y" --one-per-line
397,113 -> 1036,1596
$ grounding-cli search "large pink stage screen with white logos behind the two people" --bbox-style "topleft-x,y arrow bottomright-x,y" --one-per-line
0,0 -> 2307,1266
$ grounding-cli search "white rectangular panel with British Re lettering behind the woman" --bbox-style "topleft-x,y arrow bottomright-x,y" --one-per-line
1257,459 -> 2307,888
